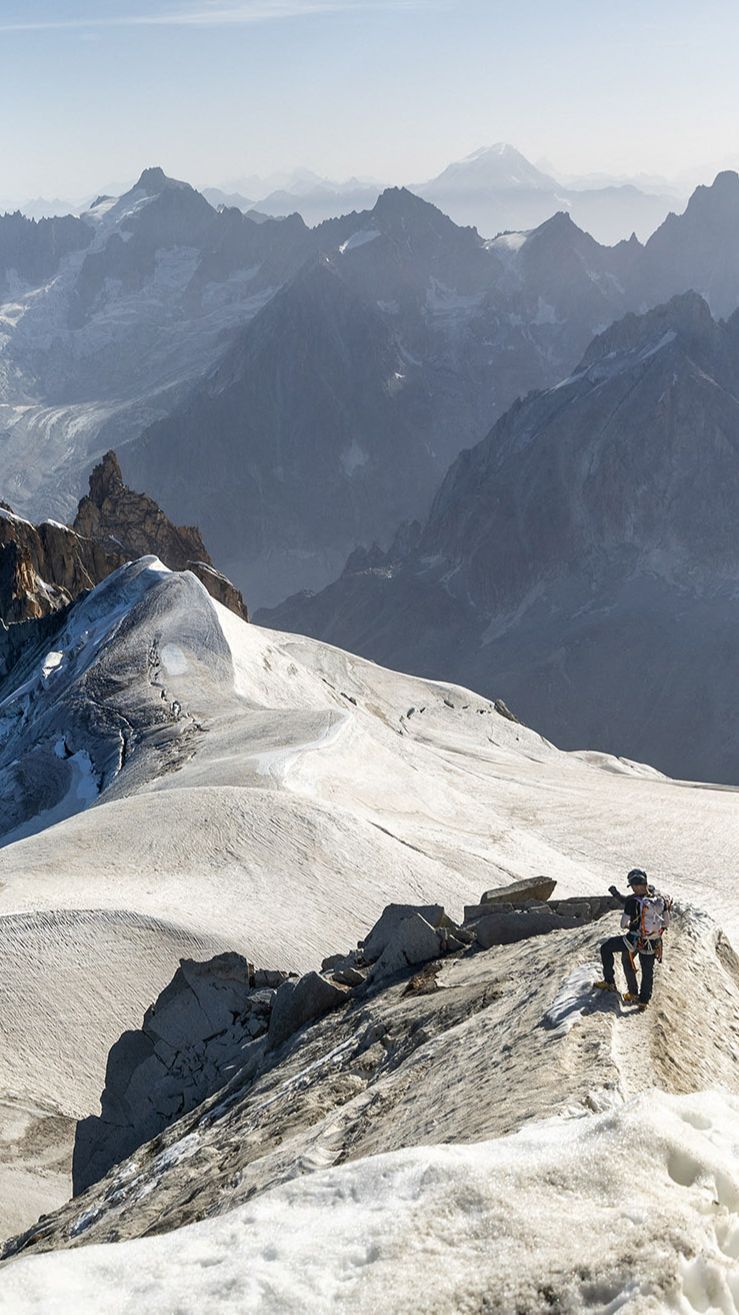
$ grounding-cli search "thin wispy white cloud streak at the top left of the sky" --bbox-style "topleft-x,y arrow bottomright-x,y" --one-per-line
0,0 -> 433,33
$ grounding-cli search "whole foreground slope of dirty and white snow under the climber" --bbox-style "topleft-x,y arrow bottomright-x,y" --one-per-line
0,909 -> 739,1315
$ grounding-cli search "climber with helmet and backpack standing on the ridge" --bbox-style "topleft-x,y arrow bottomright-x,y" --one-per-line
596,868 -> 672,1010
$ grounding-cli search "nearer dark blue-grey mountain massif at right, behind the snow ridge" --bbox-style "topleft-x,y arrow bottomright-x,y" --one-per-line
260,293 -> 739,782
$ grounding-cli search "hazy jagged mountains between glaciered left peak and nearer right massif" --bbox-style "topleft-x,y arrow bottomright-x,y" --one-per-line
121,165 -> 739,605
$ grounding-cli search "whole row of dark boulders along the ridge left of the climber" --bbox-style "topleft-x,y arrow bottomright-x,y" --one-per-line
64,877 -> 621,1194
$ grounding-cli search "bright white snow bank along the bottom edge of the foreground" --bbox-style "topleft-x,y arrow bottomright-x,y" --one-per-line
0,1091 -> 739,1315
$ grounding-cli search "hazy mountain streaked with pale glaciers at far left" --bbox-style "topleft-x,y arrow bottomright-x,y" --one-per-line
0,170 -> 316,521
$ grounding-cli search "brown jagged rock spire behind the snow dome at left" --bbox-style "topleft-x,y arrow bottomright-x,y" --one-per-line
74,451 -> 249,621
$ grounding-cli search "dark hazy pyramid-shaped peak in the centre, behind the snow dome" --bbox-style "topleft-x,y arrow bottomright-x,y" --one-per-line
125,259 -> 439,597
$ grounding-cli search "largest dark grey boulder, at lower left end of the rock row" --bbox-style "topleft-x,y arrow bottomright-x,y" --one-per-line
72,953 -> 261,1194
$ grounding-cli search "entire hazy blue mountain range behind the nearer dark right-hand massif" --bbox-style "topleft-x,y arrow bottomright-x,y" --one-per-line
0,156 -> 739,636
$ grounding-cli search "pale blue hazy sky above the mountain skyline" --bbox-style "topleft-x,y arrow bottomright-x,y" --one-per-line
0,0 -> 739,200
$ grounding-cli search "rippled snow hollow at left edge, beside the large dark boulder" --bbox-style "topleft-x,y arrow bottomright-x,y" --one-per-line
0,907 -> 230,1236
